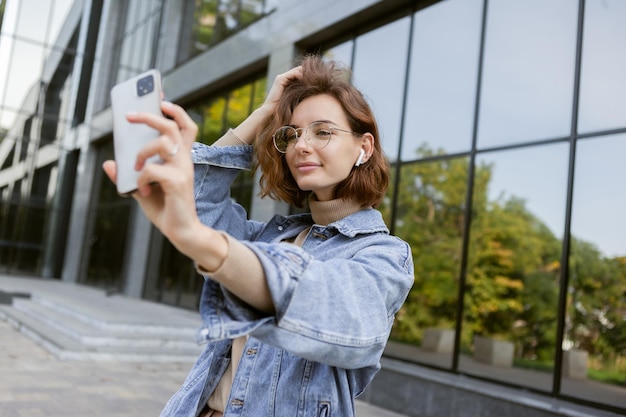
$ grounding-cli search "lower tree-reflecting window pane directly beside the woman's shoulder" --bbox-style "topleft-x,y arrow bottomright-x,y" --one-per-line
381,158 -> 468,368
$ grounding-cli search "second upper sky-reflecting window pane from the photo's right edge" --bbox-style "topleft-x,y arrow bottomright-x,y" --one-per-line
478,0 -> 578,148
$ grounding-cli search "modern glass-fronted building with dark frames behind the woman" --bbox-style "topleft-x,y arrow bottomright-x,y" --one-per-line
0,0 -> 626,416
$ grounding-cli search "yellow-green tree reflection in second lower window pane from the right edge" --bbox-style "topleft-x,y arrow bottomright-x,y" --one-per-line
462,188 -> 561,360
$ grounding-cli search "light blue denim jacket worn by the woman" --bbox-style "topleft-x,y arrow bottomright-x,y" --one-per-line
161,144 -> 413,417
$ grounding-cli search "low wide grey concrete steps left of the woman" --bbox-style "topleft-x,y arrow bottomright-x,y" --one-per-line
0,278 -> 202,363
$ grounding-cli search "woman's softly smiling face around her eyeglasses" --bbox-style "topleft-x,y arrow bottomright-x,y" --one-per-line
285,94 -> 364,201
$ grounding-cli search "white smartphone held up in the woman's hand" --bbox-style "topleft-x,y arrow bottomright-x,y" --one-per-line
111,69 -> 163,196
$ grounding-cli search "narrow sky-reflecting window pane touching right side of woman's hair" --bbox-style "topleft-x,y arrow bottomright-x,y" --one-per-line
353,17 -> 410,161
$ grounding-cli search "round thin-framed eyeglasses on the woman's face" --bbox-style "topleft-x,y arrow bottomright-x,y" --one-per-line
272,122 -> 358,153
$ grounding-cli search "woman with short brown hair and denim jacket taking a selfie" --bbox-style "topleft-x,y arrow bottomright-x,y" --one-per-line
104,56 -> 413,417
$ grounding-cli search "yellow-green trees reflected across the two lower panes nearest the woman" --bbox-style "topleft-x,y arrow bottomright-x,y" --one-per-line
390,146 -> 560,358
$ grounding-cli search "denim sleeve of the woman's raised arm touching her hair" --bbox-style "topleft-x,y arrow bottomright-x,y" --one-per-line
191,143 -> 262,239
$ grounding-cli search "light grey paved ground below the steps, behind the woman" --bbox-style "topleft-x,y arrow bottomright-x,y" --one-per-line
0,284 -> 402,417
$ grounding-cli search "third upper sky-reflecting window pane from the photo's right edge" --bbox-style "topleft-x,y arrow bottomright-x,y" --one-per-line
402,0 -> 483,160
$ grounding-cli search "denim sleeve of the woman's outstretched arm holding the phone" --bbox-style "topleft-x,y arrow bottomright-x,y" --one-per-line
197,234 -> 413,369
